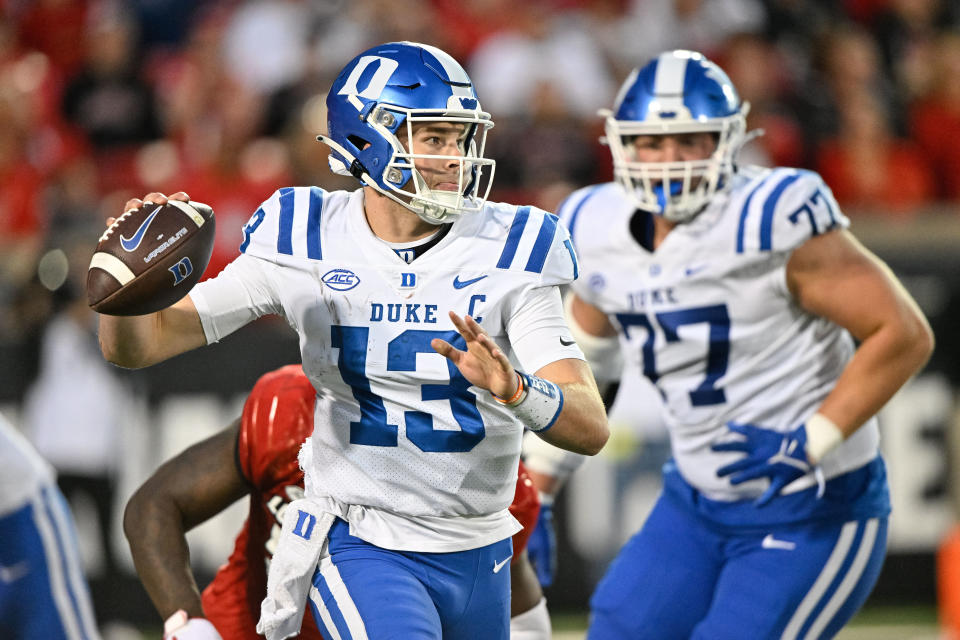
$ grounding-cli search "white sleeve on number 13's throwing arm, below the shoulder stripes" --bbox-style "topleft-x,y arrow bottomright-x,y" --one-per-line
189,254 -> 282,344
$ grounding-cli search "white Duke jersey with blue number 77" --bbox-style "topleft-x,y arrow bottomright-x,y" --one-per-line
560,167 -> 879,500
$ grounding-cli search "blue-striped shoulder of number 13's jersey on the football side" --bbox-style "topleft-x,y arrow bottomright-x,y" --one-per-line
240,187 -> 326,260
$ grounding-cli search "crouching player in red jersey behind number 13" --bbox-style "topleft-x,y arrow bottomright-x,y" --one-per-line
124,365 -> 550,640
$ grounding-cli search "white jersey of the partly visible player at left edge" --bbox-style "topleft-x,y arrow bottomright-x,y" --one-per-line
0,415 -> 56,516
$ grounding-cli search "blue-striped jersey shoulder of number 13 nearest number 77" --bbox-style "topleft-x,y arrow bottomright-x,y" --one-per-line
497,206 -> 580,284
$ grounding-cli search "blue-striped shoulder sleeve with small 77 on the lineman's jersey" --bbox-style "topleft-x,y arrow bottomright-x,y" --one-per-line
736,169 -> 850,253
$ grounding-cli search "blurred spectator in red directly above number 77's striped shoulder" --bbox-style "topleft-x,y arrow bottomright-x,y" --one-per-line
817,91 -> 933,217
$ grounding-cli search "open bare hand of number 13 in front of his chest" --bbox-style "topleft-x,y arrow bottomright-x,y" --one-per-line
430,311 -> 517,398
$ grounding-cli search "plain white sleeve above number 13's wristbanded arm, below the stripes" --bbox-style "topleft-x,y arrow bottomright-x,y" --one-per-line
506,286 -> 584,373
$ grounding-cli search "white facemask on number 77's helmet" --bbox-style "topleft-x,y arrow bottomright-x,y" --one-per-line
601,103 -> 749,222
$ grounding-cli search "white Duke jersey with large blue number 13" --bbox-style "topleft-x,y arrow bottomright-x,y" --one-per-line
190,187 -> 583,551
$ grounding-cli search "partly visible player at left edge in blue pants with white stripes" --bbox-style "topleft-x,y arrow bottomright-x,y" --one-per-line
0,415 -> 100,640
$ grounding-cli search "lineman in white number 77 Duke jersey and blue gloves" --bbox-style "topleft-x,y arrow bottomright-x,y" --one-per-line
561,51 -> 933,640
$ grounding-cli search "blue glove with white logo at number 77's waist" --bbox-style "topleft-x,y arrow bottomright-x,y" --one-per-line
710,422 -> 819,506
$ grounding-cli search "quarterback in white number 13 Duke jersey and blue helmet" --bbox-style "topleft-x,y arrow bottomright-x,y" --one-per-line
100,42 -> 608,640
